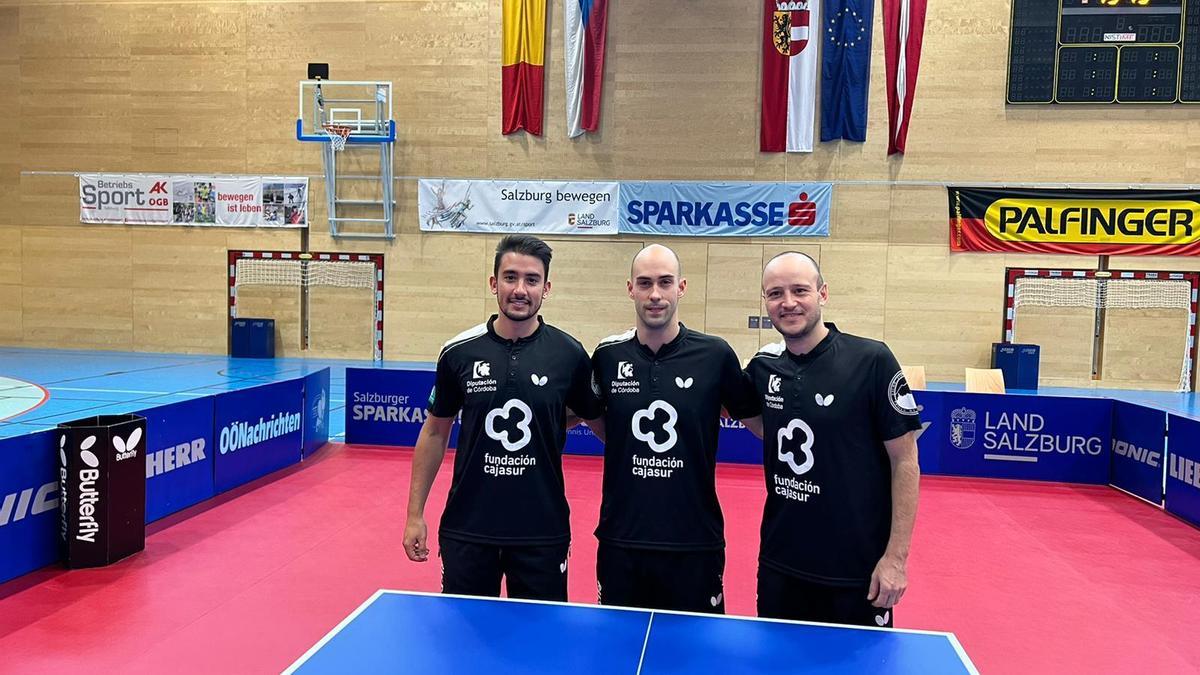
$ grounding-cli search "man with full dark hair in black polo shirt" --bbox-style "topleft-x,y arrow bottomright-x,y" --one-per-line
404,235 -> 601,601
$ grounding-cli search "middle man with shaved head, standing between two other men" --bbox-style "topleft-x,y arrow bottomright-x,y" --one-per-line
592,245 -> 758,613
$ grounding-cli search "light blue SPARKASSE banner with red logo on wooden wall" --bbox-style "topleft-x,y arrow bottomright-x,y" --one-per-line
620,181 -> 833,237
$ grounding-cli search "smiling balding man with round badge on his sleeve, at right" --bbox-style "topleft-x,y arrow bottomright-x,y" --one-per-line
746,252 -> 922,626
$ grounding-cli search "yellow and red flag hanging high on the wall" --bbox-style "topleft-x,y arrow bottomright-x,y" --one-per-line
500,0 -> 546,136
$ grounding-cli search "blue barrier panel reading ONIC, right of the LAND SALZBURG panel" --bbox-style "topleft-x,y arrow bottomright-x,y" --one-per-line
1109,401 -> 1166,504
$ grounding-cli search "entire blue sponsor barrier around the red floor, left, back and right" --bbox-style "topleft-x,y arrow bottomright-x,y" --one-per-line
0,369 -> 1200,583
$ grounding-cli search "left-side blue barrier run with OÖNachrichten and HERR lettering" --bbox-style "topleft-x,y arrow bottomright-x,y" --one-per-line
0,369 -> 330,583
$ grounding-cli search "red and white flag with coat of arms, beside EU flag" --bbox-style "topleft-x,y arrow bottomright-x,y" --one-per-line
760,0 -> 821,153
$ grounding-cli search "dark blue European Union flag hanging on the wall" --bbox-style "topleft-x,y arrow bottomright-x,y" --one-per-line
821,0 -> 875,143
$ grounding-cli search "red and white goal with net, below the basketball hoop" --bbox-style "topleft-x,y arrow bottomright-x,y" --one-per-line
229,250 -> 384,362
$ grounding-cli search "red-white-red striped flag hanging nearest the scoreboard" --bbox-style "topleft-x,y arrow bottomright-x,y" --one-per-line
883,0 -> 925,155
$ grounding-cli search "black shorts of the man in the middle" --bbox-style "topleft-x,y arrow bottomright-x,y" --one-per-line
596,542 -> 725,614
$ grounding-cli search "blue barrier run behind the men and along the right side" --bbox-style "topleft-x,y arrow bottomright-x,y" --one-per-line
346,368 -> 1200,526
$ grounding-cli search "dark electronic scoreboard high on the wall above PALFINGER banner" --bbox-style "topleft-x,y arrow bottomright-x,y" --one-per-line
1007,0 -> 1200,103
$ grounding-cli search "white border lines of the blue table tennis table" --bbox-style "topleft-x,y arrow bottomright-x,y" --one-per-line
283,589 -> 979,675
